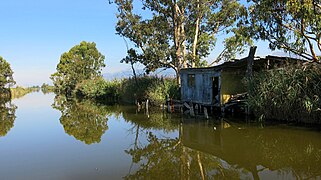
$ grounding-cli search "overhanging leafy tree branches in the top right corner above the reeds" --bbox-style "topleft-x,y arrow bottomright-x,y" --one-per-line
247,0 -> 321,61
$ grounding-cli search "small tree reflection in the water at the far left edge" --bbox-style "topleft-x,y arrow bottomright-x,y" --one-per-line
0,99 -> 17,136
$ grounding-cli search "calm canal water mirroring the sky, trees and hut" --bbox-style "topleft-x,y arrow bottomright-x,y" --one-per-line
0,93 -> 321,180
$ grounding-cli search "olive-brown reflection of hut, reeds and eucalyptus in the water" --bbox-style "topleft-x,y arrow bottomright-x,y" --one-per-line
125,117 -> 321,179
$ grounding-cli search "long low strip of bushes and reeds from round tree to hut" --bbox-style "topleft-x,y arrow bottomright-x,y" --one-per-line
75,76 -> 180,105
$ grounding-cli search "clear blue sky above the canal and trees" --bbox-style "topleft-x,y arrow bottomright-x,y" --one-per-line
0,0 -> 276,86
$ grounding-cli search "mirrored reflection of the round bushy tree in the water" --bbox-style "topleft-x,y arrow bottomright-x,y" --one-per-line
52,96 -> 111,144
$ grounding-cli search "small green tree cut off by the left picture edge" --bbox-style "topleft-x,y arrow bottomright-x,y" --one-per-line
0,56 -> 16,91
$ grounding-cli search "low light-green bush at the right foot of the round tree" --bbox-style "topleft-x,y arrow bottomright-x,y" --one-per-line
76,77 -> 121,103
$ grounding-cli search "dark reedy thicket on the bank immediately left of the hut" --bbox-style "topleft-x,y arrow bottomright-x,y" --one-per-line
120,76 -> 180,105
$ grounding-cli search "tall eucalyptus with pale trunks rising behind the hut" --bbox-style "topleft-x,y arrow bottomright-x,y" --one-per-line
114,0 -> 250,81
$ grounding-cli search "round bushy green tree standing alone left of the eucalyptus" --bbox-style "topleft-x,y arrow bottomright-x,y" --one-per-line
51,41 -> 105,95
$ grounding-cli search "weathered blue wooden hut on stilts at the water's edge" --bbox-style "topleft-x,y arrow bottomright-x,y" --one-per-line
180,49 -> 301,113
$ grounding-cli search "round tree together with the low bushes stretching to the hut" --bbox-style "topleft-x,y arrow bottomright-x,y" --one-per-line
50,42 -> 179,105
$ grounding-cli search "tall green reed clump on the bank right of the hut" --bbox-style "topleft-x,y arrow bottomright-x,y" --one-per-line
248,64 -> 321,123
